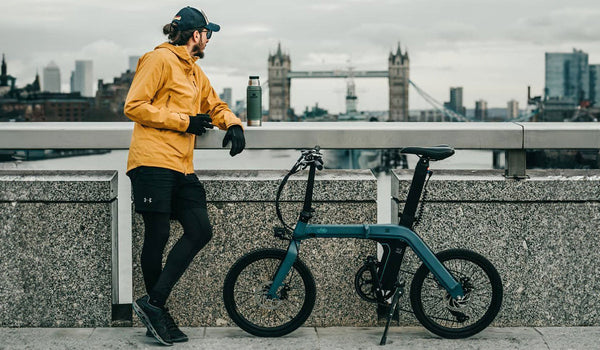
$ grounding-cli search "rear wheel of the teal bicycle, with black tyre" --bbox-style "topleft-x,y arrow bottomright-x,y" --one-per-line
410,249 -> 503,339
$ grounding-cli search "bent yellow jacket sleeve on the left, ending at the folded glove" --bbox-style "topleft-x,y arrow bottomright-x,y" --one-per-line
124,52 -> 189,132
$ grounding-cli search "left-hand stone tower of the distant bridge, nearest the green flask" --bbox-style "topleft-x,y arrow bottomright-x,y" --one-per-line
269,43 -> 291,121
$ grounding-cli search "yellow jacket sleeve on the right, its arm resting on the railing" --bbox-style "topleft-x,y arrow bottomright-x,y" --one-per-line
200,70 -> 243,130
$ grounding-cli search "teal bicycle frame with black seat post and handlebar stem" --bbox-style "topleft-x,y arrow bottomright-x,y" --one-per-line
267,157 -> 464,299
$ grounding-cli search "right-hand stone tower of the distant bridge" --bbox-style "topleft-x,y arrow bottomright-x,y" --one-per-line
388,43 -> 410,122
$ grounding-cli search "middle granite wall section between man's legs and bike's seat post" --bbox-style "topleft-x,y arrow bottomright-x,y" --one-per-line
133,171 -> 377,326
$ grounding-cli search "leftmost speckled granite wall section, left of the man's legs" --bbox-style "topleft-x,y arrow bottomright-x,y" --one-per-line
0,171 -> 117,327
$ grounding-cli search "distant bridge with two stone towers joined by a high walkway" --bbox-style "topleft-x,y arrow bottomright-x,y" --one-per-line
268,44 -> 410,121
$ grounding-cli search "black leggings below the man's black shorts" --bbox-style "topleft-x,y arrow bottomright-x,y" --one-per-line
141,208 -> 212,307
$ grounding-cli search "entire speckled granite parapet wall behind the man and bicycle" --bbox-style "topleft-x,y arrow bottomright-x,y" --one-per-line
7,170 -> 600,327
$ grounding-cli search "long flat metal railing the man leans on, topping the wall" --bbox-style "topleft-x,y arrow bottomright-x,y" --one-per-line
0,122 -> 600,177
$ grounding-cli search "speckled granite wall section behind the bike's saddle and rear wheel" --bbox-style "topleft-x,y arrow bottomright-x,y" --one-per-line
393,170 -> 600,326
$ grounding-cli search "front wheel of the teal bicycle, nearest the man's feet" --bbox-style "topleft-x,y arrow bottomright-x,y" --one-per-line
223,249 -> 316,337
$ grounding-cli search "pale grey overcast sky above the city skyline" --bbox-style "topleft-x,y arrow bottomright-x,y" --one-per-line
0,0 -> 600,112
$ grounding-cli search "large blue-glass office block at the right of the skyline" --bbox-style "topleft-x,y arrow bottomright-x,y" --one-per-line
544,49 -> 590,104
